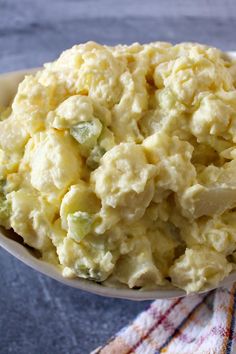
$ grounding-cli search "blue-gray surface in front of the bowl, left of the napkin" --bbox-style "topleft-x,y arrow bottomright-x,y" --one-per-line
0,250 -> 148,354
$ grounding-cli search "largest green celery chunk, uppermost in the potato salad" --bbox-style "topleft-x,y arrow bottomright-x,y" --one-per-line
70,119 -> 102,148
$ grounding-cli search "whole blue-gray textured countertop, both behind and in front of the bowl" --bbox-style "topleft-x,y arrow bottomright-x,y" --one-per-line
0,0 -> 236,354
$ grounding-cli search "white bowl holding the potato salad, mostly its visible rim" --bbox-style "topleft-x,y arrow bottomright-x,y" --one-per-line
0,52 -> 236,300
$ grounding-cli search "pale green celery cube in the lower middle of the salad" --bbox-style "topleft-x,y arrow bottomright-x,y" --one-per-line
67,211 -> 93,242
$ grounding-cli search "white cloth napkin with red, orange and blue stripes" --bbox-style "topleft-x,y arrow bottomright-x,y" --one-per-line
93,283 -> 236,354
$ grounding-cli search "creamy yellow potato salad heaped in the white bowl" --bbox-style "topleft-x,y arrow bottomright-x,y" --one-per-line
0,42 -> 236,293
